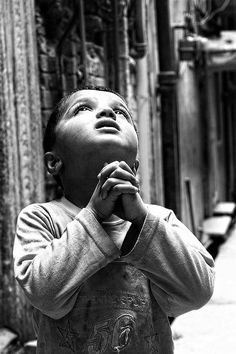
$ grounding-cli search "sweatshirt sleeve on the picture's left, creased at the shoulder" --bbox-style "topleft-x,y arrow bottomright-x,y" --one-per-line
13,204 -> 120,319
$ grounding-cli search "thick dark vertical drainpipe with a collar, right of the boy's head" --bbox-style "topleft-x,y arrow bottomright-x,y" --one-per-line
155,0 -> 181,217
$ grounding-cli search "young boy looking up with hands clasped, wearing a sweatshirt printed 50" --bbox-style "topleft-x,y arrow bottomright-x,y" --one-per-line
14,88 -> 214,354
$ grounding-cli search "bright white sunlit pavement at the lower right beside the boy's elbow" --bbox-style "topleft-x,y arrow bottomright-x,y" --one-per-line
172,225 -> 236,354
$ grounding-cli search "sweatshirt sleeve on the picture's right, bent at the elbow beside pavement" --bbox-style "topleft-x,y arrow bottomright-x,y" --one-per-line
122,205 -> 214,317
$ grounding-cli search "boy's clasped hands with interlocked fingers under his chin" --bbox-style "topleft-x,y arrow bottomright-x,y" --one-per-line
87,161 -> 147,224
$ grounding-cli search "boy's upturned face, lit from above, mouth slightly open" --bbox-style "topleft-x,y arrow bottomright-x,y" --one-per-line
56,90 -> 138,180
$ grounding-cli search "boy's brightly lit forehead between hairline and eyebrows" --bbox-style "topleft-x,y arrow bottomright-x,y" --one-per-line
67,89 -> 128,108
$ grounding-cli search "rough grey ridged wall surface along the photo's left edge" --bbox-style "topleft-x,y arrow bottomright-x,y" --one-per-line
0,0 -> 44,335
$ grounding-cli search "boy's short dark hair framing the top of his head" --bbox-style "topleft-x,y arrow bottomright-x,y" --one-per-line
43,85 -> 137,153
